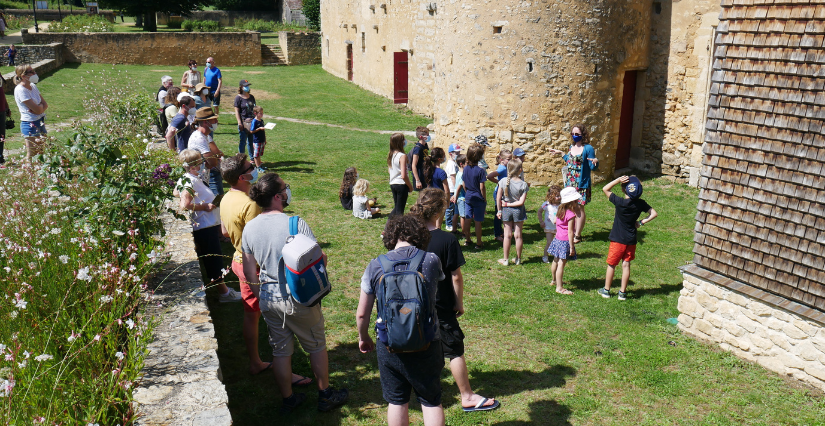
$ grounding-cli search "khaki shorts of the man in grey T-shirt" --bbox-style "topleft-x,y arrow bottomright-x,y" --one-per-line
260,299 -> 327,357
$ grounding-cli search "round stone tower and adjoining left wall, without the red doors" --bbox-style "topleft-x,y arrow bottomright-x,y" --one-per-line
321,0 -> 652,184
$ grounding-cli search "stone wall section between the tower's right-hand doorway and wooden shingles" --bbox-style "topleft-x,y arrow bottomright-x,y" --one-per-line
630,0 -> 721,186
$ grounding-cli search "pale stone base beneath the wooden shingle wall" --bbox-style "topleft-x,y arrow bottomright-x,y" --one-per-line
678,273 -> 825,390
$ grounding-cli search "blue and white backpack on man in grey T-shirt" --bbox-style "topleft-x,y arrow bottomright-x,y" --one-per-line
278,216 -> 332,307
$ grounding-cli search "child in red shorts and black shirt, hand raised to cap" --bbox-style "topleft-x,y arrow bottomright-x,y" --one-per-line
598,176 -> 656,300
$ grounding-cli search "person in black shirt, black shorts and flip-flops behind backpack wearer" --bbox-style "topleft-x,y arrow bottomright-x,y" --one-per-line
410,188 -> 501,412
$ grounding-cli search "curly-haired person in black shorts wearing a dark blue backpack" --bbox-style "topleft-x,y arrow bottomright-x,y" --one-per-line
356,214 -> 445,426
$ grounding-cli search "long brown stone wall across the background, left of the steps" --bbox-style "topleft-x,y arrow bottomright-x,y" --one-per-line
23,31 -> 261,67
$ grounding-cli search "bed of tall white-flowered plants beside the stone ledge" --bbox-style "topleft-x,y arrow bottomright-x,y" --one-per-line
0,71 -> 180,424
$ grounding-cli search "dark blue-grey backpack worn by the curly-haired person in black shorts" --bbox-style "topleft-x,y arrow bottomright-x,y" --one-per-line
375,250 -> 438,353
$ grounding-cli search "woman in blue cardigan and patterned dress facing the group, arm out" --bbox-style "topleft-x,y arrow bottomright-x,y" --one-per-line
550,124 -> 599,243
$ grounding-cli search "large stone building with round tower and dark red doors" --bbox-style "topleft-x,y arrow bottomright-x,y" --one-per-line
321,0 -> 720,183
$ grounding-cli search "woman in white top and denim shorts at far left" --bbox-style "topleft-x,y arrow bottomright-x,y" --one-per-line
14,64 -> 49,161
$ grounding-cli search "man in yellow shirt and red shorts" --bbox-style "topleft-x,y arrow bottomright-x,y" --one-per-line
220,154 -> 312,386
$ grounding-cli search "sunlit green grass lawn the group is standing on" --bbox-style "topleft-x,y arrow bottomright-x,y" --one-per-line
3,64 -> 825,425
